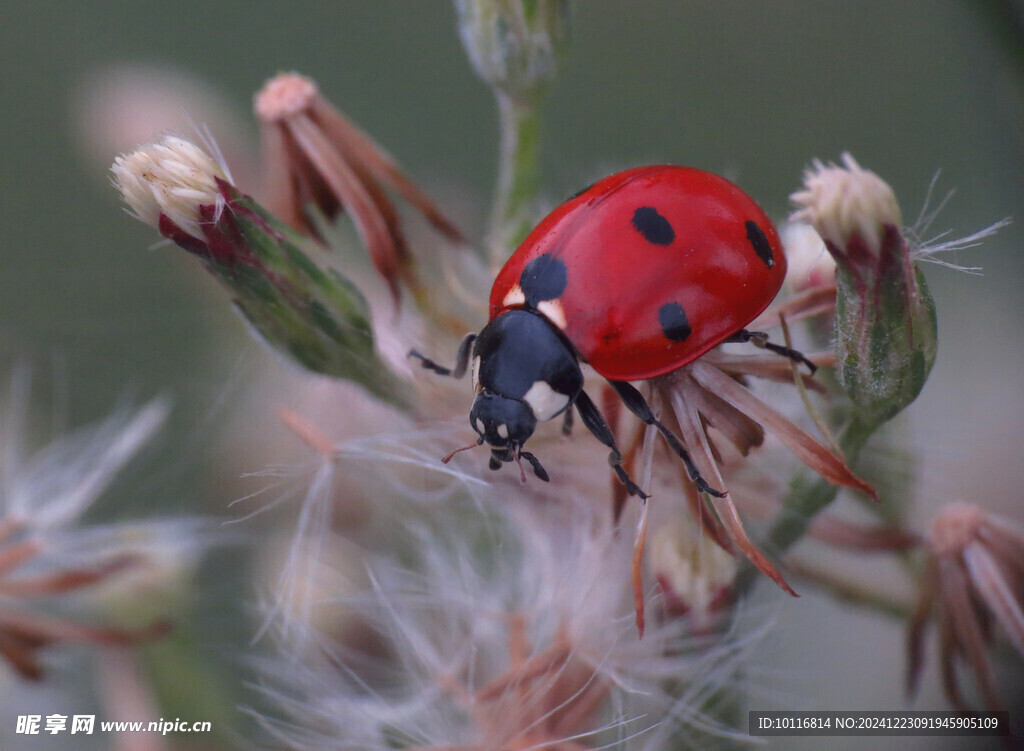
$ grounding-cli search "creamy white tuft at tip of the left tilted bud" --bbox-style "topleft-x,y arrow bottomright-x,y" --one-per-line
111,135 -> 227,240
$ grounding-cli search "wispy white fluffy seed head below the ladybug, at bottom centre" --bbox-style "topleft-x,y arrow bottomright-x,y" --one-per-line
247,491 -> 751,751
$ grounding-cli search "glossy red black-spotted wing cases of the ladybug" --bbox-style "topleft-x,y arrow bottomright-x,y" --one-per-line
490,165 -> 786,381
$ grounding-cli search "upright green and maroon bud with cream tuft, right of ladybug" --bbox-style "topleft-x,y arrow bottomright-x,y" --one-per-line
791,154 -> 938,424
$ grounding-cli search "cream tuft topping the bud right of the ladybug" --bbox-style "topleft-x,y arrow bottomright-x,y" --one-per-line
790,153 -> 902,253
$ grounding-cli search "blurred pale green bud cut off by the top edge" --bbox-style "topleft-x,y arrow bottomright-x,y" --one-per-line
455,0 -> 568,100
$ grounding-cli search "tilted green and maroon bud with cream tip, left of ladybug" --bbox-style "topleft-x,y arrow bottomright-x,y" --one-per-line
112,137 -> 395,398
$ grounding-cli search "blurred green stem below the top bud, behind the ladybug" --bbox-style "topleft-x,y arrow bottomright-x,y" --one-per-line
487,89 -> 541,266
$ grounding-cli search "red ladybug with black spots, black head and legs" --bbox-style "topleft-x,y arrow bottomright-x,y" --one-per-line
410,165 -> 814,498
